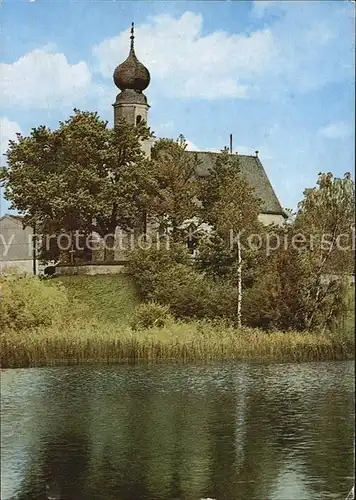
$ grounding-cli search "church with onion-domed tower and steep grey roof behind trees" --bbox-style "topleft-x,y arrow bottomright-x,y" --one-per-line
113,23 -> 287,225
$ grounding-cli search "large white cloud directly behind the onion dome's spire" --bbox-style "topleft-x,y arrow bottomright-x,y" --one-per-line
93,12 -> 275,100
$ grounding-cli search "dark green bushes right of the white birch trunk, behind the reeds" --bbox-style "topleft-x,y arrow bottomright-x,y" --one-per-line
242,248 -> 351,331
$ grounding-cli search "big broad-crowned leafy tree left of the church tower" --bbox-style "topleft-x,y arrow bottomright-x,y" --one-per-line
0,109 -> 155,260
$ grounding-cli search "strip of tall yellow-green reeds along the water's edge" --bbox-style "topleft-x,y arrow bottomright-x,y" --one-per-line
1,322 -> 354,368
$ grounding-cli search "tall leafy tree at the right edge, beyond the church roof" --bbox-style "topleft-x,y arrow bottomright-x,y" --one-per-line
295,172 -> 355,329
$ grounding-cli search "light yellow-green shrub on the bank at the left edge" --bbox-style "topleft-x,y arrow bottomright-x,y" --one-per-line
0,274 -> 70,332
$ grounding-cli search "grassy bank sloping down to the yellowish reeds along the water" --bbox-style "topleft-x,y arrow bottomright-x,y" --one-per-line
0,276 -> 354,368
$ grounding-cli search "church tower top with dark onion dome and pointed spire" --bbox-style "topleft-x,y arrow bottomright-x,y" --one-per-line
113,23 -> 151,126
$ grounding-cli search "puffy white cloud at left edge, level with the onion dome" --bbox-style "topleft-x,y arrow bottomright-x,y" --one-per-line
0,46 -> 92,108
